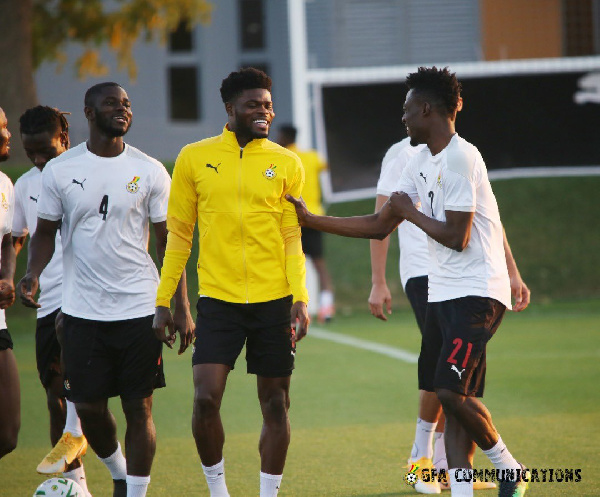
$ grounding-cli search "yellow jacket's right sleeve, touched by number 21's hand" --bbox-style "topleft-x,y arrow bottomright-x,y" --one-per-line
281,159 -> 308,303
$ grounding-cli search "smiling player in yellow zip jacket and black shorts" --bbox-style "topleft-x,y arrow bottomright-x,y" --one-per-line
154,68 -> 309,497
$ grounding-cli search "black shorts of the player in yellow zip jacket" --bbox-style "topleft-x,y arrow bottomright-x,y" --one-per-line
192,295 -> 296,378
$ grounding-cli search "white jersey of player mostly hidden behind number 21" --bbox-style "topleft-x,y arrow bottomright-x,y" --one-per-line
377,138 -> 429,289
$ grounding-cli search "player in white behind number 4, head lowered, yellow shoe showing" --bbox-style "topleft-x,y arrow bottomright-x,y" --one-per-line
12,105 -> 89,493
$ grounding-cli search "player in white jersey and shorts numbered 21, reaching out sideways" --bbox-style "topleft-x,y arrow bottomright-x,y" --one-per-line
289,67 -> 527,497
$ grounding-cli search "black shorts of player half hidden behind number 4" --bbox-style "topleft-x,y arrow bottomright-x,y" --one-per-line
35,309 -> 62,388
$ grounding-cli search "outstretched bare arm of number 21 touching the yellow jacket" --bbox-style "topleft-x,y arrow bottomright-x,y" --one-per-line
285,195 -> 402,240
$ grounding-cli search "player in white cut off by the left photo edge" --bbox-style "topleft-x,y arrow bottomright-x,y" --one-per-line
0,109 -> 21,459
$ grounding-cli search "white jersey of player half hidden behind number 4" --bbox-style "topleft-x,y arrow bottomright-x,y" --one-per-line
12,167 -> 62,319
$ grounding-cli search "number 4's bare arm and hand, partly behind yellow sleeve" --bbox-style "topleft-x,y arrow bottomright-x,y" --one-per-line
154,221 -> 196,354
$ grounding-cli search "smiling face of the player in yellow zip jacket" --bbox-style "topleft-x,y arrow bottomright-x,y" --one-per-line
225,88 -> 275,146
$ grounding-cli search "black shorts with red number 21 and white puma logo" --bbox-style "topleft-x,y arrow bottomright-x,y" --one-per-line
419,297 -> 506,397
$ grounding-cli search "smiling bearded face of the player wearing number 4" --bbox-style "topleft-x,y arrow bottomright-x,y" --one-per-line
86,86 -> 133,138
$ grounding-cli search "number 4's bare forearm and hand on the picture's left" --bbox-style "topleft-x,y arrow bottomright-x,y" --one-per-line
17,217 -> 60,308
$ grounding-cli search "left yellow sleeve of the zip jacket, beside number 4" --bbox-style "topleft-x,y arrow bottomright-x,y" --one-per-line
156,149 -> 198,307
